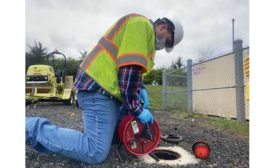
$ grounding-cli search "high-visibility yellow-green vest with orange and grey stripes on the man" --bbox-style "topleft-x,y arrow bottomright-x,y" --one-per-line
80,14 -> 155,101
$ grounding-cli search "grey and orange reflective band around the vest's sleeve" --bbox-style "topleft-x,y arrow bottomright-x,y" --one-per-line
117,53 -> 147,69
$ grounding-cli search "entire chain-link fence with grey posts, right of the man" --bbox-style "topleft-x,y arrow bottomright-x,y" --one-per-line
162,40 -> 249,121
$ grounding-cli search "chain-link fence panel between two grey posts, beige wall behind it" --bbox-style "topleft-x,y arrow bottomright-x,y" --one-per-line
192,53 -> 236,118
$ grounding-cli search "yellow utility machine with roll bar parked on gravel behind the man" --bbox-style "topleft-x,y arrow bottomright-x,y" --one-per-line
25,50 -> 75,105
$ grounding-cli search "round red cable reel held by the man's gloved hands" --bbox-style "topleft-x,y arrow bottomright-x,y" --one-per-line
118,114 -> 160,156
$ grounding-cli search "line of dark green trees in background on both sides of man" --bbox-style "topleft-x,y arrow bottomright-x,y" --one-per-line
25,41 -> 188,85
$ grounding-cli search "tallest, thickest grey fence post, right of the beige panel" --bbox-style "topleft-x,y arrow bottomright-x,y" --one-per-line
233,39 -> 245,121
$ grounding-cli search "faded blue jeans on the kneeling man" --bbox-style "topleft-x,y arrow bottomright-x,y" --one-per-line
26,91 -> 121,164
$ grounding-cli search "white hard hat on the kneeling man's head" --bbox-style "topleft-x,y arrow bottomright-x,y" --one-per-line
165,18 -> 184,52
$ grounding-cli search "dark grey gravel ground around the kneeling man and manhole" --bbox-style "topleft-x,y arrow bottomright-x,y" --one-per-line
25,103 -> 249,168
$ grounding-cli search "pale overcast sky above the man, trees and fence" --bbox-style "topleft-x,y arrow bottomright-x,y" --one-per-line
26,0 -> 249,68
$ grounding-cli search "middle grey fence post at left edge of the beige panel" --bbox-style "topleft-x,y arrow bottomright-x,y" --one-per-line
187,59 -> 193,112
